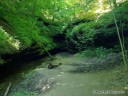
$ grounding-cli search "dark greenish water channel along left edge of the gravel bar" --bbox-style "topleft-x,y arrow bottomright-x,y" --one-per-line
0,57 -> 49,94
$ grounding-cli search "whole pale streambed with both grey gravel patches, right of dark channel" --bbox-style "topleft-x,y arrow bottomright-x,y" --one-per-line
4,52 -> 126,96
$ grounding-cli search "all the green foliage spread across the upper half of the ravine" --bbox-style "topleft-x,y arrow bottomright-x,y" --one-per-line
0,0 -> 128,65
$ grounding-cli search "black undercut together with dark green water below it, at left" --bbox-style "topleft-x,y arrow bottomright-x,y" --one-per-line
0,48 -> 67,94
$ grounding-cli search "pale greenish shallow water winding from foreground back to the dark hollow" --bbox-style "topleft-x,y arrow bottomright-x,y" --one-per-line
0,53 -> 127,96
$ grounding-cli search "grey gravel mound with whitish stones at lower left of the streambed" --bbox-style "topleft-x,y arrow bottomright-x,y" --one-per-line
9,70 -> 55,96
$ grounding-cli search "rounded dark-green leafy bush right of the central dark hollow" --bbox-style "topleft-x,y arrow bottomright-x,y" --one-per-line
66,20 -> 99,50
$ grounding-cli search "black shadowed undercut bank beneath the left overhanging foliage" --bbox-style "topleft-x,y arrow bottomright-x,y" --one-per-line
0,47 -> 67,80
